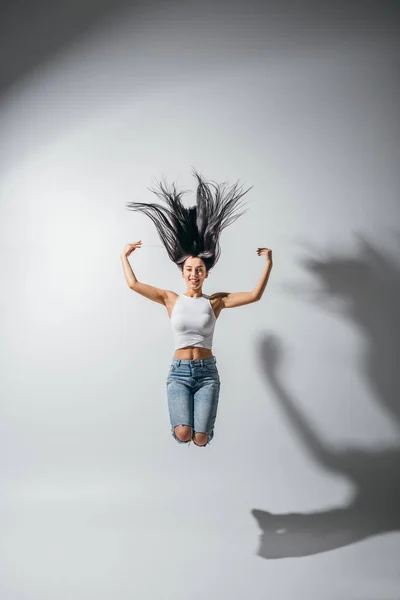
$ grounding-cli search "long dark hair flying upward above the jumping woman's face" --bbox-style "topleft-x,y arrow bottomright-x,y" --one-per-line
127,169 -> 251,271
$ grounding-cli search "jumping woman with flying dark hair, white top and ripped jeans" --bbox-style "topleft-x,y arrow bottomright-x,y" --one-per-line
121,171 -> 272,446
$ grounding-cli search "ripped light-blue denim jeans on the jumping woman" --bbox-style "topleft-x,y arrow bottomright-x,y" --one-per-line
167,356 -> 220,444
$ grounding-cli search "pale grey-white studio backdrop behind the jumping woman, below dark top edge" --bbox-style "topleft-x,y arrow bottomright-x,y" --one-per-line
0,2 -> 400,600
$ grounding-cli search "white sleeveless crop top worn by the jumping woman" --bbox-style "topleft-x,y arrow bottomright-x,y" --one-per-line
170,294 -> 217,350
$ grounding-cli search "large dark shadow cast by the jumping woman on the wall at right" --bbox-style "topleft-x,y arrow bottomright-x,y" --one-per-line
252,241 -> 400,559
